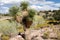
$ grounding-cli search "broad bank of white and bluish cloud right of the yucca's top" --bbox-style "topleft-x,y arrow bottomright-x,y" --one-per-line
30,0 -> 60,10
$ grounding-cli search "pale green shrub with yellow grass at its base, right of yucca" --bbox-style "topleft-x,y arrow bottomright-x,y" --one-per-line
31,15 -> 48,29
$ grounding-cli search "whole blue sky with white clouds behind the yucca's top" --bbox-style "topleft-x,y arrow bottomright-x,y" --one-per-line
0,0 -> 60,13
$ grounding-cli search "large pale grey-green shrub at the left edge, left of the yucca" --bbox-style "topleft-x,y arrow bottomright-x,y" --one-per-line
0,20 -> 18,36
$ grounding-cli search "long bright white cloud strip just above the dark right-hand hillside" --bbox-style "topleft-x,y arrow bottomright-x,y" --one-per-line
30,5 -> 59,11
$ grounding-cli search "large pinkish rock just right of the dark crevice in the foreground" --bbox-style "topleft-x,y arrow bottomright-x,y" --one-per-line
25,30 -> 44,40
